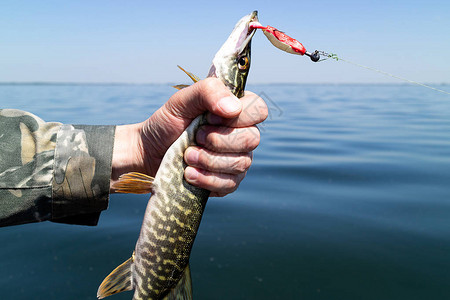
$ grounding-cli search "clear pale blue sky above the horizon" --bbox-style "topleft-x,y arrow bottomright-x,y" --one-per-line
0,0 -> 450,84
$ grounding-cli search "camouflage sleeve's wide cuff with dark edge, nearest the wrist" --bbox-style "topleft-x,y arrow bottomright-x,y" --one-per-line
51,125 -> 115,225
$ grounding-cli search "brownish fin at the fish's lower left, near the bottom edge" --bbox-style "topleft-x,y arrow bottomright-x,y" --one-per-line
97,254 -> 134,299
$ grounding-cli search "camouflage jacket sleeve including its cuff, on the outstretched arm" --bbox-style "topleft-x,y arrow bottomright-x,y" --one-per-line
0,109 -> 115,226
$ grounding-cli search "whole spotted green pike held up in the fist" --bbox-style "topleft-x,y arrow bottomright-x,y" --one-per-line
97,11 -> 258,300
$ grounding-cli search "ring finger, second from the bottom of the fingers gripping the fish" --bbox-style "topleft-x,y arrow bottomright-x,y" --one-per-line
184,147 -> 252,174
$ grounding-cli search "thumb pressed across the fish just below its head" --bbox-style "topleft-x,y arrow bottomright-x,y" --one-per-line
165,78 -> 242,119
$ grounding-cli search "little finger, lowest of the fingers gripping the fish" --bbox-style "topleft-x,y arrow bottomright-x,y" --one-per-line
184,166 -> 245,195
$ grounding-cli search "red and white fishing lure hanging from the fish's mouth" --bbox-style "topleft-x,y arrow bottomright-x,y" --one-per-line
249,22 -> 320,62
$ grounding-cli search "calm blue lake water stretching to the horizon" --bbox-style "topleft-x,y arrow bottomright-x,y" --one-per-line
0,85 -> 450,299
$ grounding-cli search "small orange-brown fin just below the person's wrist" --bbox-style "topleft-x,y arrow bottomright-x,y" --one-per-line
112,172 -> 153,194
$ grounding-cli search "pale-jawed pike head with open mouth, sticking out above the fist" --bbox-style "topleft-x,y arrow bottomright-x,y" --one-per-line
208,11 -> 258,98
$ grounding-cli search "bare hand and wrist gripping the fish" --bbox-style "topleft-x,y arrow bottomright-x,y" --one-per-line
111,78 -> 268,196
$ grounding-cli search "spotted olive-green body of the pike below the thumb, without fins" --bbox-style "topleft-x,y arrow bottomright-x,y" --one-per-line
133,116 -> 209,299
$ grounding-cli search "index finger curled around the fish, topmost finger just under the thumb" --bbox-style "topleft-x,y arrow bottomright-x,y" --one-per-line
207,91 -> 269,127
